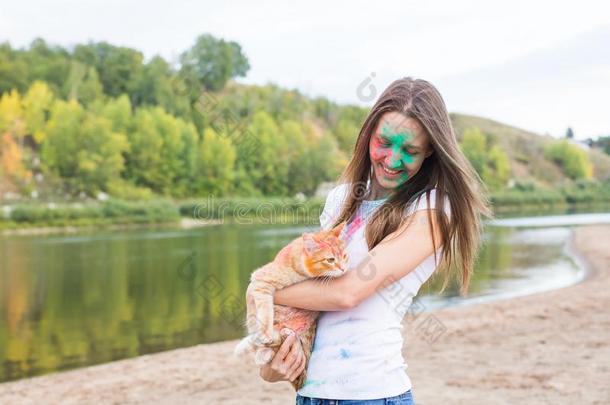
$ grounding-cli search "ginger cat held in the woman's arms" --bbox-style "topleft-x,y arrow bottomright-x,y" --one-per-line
234,223 -> 347,390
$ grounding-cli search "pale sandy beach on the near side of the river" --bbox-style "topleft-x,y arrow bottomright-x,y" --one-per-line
0,226 -> 610,405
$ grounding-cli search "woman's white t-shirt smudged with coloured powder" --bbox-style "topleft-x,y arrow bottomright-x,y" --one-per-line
298,184 -> 450,400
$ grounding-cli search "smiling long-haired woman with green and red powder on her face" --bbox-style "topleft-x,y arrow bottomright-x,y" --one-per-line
260,77 -> 489,404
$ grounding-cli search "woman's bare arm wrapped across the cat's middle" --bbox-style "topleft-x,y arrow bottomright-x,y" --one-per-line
274,210 -> 443,311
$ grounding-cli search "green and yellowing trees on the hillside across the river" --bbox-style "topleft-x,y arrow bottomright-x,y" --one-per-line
0,34 -> 595,205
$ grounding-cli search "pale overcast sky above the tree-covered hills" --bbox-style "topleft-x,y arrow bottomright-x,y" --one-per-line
0,0 -> 610,138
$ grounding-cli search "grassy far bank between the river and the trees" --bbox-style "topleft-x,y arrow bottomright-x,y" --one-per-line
0,184 -> 610,229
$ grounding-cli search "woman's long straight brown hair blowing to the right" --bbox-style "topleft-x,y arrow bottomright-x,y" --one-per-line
334,77 -> 491,295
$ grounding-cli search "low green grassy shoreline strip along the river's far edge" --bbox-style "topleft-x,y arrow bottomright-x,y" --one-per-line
0,193 -> 610,236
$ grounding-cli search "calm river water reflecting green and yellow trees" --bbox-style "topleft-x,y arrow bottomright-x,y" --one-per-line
0,211 -> 600,381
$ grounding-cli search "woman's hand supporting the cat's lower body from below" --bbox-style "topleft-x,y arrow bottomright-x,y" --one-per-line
260,328 -> 305,382
